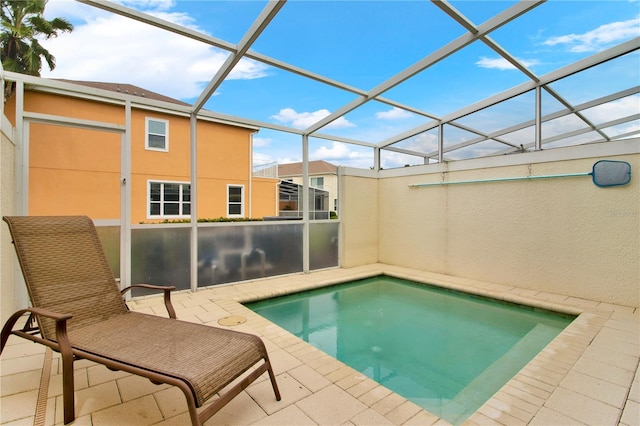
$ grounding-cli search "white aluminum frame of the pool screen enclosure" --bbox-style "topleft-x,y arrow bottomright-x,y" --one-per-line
2,0 -> 640,280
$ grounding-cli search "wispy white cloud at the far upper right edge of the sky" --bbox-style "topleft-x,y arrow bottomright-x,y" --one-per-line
543,16 -> 640,52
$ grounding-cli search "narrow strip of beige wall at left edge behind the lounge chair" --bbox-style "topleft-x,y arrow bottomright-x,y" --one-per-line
0,117 -> 16,324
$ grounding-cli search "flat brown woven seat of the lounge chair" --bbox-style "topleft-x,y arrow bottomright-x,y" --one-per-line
69,312 -> 265,406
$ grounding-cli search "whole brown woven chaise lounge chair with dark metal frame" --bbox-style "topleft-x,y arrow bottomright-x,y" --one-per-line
0,216 -> 280,425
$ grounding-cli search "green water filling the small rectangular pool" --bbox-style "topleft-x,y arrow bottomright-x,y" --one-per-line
246,276 -> 574,424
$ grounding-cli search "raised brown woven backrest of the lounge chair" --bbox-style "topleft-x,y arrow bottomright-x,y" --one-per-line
4,216 -> 127,340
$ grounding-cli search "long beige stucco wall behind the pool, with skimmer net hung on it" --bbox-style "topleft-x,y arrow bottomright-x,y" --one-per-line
343,140 -> 640,306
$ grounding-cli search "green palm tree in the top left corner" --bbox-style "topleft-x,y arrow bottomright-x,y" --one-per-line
0,0 -> 73,97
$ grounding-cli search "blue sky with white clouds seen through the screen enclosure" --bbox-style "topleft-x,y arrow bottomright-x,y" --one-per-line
42,0 -> 640,168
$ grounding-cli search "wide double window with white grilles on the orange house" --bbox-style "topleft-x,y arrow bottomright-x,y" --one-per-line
147,181 -> 191,218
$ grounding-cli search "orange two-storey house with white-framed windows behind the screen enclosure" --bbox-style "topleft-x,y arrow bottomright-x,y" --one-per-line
5,81 -> 279,223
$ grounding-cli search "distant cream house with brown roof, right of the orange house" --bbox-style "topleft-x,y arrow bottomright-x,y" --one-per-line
278,160 -> 338,212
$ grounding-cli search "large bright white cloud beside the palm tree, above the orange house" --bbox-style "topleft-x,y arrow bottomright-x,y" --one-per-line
42,0 -> 268,99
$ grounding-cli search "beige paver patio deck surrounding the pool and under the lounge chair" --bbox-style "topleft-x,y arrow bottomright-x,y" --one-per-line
0,264 -> 640,426
